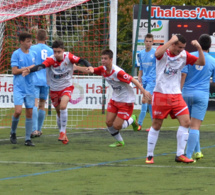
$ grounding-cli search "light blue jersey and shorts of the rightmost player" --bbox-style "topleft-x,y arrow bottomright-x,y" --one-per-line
182,52 -> 215,120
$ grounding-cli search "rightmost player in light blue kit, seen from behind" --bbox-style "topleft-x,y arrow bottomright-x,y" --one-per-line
181,34 -> 215,159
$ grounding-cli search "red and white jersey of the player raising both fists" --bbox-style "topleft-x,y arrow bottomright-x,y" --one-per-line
154,50 -> 198,94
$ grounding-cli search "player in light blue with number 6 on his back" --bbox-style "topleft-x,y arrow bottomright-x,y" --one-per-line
30,29 -> 53,138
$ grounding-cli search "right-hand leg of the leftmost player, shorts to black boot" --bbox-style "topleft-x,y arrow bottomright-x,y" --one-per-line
24,94 -> 35,146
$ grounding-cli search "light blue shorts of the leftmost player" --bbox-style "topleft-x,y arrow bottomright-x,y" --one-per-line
13,92 -> 35,108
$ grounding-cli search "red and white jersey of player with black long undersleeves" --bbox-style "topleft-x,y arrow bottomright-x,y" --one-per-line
43,52 -> 80,91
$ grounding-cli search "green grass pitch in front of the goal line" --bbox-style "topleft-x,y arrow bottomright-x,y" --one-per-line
0,111 -> 215,195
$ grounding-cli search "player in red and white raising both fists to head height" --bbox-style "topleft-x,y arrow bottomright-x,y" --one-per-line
146,35 -> 205,164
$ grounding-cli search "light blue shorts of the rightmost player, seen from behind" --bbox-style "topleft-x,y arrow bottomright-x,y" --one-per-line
182,90 -> 209,121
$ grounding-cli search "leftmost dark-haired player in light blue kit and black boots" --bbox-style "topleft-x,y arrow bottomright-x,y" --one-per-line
10,32 -> 36,146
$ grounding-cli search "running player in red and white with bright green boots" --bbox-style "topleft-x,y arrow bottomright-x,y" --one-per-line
76,49 -> 151,147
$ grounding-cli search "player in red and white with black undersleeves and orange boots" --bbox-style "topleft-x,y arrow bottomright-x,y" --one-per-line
22,40 -> 91,144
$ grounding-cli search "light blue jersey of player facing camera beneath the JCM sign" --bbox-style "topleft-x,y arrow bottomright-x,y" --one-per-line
138,48 -> 156,83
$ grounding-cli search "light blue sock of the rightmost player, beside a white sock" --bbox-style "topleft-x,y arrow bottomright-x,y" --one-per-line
186,129 -> 199,158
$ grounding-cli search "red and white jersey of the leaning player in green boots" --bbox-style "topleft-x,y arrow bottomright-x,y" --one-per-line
94,64 -> 135,103
